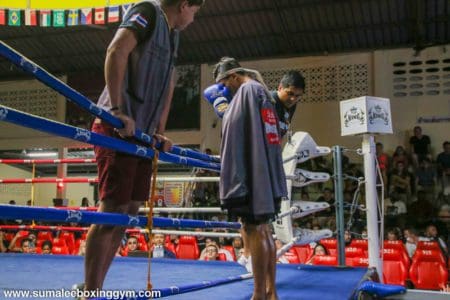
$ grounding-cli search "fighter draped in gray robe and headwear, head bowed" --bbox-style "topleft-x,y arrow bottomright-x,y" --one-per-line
214,57 -> 287,299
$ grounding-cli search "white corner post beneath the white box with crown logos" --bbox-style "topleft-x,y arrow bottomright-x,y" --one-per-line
362,134 -> 383,282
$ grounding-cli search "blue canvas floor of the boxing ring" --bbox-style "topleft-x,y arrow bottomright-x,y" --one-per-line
0,254 -> 367,300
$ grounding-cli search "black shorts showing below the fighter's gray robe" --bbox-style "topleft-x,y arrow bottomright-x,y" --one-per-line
221,196 -> 281,225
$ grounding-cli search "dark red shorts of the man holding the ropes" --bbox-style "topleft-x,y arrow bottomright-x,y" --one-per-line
92,119 -> 152,205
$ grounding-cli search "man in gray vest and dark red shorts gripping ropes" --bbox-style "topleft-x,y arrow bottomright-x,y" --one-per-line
84,0 -> 204,291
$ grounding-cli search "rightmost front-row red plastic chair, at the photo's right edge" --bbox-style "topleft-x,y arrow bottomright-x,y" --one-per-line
409,249 -> 448,290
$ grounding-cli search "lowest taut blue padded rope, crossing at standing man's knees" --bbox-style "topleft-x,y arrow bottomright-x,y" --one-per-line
0,205 -> 241,229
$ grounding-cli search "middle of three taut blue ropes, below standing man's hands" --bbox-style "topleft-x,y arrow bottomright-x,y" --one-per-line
0,105 -> 220,172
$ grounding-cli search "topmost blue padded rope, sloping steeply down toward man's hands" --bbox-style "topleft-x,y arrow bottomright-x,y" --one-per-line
0,41 -> 220,163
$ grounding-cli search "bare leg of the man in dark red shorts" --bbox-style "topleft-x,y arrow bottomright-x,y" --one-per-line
85,201 -> 139,291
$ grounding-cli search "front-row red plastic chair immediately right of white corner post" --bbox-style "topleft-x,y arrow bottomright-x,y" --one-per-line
383,249 -> 408,286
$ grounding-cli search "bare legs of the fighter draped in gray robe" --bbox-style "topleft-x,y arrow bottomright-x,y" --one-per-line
242,224 -> 270,300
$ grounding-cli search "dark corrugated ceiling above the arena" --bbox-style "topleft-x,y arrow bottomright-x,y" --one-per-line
0,0 -> 450,80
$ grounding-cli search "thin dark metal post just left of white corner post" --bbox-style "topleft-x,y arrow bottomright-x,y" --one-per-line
333,146 -> 345,267
